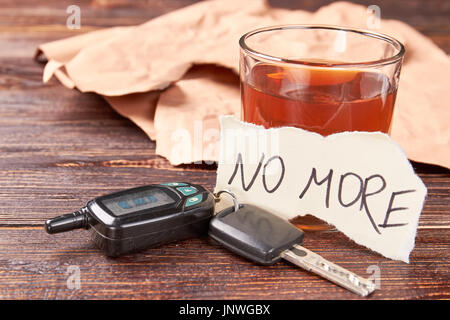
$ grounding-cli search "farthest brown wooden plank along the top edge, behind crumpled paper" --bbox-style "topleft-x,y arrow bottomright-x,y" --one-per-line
0,0 -> 450,35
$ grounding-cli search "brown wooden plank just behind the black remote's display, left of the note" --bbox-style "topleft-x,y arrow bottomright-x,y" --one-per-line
0,168 -> 450,228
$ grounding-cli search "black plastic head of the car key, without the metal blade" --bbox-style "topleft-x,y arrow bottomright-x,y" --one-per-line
209,204 -> 304,265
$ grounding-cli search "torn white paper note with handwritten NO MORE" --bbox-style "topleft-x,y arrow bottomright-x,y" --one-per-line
216,116 -> 427,262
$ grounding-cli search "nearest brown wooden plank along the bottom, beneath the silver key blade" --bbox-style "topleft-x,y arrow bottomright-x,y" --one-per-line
0,227 -> 450,299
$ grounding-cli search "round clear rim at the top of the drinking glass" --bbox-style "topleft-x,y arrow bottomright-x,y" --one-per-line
239,24 -> 405,68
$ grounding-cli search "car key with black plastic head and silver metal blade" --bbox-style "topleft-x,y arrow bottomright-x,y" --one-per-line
208,202 -> 375,296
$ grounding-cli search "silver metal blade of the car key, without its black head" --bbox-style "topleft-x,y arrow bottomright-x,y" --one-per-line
281,244 -> 375,297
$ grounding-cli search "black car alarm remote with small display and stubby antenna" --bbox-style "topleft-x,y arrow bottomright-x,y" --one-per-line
45,182 -> 215,257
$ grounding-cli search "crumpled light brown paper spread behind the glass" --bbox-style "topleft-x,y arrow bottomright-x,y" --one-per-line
38,0 -> 450,168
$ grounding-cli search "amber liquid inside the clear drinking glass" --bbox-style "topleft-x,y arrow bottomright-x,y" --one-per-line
241,64 -> 396,231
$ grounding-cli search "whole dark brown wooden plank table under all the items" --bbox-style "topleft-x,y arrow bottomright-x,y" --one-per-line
0,0 -> 450,299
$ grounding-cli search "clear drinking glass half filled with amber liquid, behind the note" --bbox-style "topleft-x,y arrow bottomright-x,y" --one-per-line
239,25 -> 405,230
